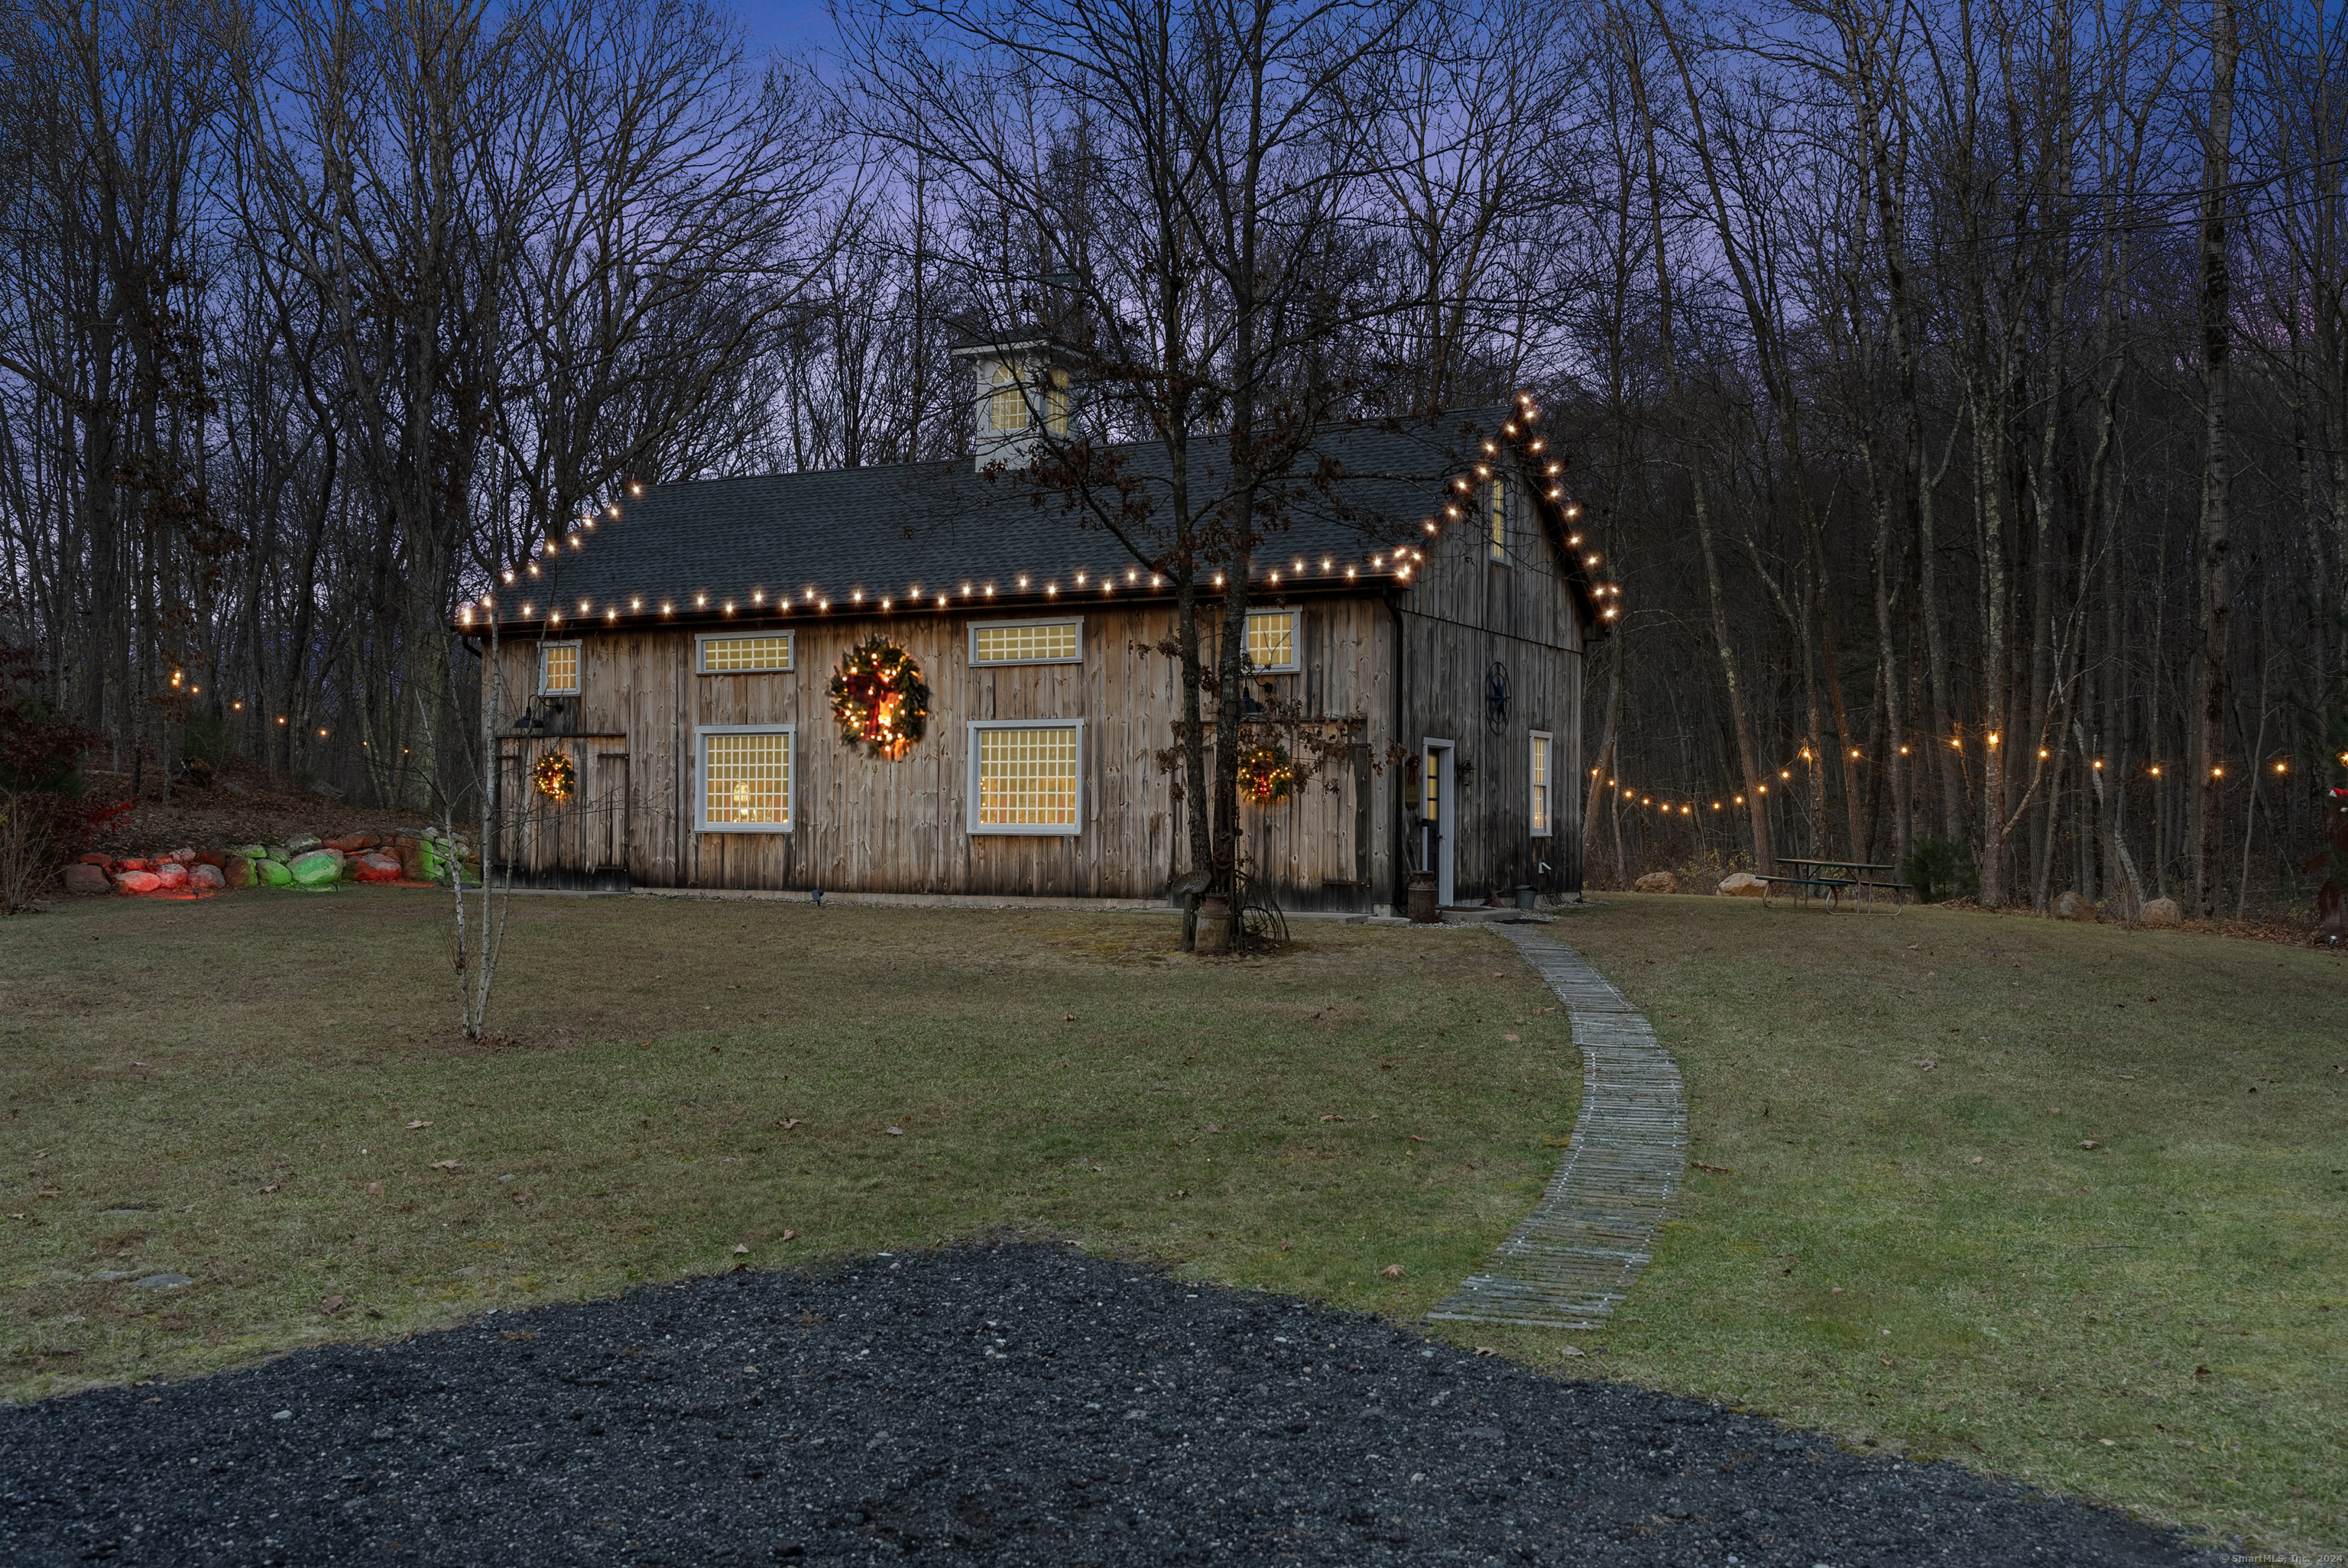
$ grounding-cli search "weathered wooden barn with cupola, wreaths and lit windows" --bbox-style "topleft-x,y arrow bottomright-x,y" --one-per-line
458,358 -> 1616,913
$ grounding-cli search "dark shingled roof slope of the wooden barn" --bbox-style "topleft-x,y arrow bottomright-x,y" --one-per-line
475,403 -> 1587,627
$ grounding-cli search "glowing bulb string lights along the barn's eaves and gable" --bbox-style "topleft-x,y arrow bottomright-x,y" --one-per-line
458,392 -> 1623,629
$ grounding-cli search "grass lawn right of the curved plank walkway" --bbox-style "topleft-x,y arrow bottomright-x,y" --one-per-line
1481,894 -> 2348,1561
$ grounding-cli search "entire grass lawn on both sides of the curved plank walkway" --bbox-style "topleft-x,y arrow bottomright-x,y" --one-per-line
0,889 -> 2348,1559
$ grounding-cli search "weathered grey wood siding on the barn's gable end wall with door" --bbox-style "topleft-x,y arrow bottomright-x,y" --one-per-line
1380,465 -> 1587,904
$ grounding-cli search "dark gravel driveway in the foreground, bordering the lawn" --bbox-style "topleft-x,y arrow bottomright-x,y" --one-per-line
0,1244 -> 2217,1568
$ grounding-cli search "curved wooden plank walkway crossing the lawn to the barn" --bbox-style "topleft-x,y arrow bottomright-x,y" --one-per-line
1428,925 -> 1688,1329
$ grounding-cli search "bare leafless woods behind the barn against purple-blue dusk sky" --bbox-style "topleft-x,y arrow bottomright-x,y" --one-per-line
0,0 -> 2348,913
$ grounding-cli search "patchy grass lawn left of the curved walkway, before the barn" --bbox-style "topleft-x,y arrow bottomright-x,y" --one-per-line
0,887 -> 1580,1399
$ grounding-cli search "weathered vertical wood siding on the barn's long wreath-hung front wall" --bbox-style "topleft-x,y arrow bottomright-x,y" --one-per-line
481,596 -> 1395,909
